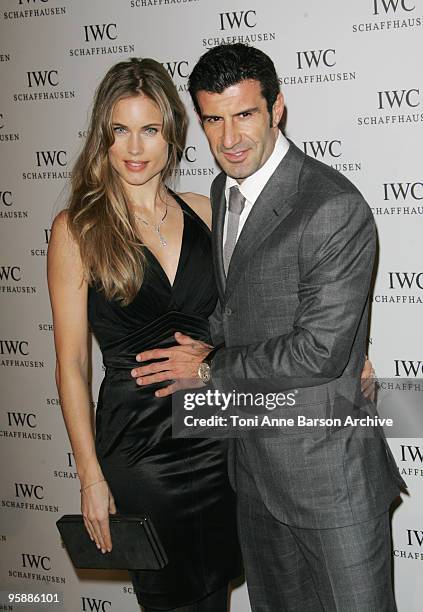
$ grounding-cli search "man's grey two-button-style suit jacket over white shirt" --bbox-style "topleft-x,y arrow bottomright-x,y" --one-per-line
211,143 -> 404,528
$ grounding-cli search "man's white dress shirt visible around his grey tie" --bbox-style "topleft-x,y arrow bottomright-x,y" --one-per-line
223,132 -> 289,244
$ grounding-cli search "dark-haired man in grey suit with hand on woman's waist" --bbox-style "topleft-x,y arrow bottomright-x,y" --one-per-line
133,44 -> 403,612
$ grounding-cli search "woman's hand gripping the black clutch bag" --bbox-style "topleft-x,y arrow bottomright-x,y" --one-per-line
81,480 -> 116,553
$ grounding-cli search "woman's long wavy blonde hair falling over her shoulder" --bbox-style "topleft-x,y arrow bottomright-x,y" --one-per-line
68,58 -> 187,305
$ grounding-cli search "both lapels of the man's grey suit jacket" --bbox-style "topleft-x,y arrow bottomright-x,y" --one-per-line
225,143 -> 304,301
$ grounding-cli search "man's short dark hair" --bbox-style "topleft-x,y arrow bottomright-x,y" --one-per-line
188,43 -> 280,117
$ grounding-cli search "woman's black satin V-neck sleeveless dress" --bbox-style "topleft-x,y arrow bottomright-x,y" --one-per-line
88,194 -> 241,610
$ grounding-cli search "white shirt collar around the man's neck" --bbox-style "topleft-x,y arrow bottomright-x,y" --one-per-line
225,131 -> 289,204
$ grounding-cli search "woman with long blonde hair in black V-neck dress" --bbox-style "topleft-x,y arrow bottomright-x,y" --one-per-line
48,59 -> 240,612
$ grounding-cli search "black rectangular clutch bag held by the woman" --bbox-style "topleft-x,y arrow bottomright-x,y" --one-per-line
56,514 -> 167,570
